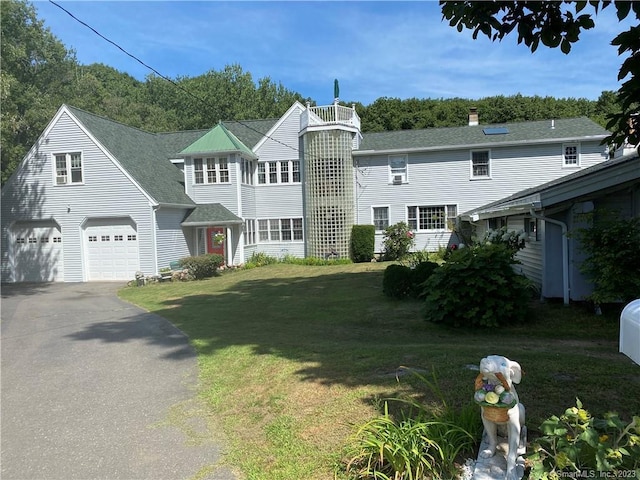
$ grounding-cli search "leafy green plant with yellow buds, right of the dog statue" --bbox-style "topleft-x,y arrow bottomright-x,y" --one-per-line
527,400 -> 640,480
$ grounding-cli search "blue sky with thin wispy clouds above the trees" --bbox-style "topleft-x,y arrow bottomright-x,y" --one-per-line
34,1 -> 627,105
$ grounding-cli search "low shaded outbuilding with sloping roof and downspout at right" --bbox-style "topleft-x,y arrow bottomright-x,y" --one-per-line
461,150 -> 640,303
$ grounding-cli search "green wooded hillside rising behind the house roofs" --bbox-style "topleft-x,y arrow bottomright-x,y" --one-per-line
0,0 -> 620,184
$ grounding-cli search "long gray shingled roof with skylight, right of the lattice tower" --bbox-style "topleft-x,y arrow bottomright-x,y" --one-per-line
354,117 -> 609,155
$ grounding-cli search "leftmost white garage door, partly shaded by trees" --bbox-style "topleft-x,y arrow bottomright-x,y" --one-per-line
11,221 -> 64,282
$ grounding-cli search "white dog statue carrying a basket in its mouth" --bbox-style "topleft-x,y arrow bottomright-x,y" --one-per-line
477,355 -> 527,480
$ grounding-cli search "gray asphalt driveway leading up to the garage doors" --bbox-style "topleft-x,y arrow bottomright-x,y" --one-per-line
0,283 -> 235,480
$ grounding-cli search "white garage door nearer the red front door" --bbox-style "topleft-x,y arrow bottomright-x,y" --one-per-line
84,218 -> 140,280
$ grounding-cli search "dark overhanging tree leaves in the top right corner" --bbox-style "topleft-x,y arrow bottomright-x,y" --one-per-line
440,0 -> 640,147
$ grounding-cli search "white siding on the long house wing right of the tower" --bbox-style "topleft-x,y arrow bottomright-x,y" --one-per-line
355,142 -> 605,250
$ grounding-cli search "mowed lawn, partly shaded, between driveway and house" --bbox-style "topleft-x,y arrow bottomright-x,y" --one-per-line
120,263 -> 640,480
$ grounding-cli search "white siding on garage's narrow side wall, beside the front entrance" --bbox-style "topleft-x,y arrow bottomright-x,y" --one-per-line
156,207 -> 190,269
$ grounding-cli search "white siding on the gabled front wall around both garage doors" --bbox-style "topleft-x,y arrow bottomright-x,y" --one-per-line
2,113 -> 155,282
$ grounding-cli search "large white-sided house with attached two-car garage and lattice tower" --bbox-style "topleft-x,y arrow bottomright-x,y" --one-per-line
1,102 -> 608,288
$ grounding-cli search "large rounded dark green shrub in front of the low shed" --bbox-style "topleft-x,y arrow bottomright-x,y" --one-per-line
424,244 -> 531,327
